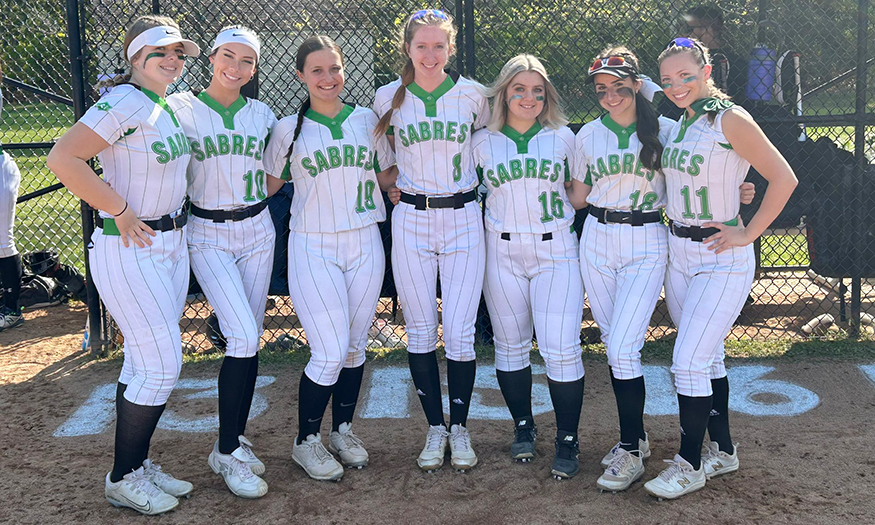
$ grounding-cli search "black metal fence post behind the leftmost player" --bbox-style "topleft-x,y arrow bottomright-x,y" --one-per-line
67,0 -> 104,354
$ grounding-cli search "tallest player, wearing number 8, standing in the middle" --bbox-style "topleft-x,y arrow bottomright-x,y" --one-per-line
374,9 -> 490,471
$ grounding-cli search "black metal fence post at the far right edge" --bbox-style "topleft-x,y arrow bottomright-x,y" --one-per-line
850,0 -> 870,336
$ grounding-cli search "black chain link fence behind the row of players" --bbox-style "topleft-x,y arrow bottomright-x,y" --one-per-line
0,0 -> 875,351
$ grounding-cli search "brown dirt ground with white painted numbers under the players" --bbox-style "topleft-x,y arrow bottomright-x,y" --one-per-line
0,300 -> 875,525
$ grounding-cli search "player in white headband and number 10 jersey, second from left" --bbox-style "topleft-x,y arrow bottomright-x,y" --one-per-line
167,26 -> 276,498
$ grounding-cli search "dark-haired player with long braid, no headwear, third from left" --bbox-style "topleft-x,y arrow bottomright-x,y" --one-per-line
264,36 -> 394,480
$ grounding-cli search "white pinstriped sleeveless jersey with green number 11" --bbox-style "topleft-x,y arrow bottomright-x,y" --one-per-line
662,106 -> 750,226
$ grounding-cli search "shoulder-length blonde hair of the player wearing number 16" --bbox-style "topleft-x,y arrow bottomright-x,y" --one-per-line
486,54 -> 568,131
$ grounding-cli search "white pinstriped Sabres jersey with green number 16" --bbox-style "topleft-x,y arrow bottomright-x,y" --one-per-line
473,122 -> 574,233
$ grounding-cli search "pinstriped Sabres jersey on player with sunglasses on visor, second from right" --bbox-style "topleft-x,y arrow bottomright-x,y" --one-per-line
574,114 -> 674,211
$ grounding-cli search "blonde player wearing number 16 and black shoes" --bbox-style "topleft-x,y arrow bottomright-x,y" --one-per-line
473,55 -> 584,479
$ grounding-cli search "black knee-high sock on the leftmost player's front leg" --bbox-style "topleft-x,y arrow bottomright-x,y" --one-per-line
109,383 -> 166,483
